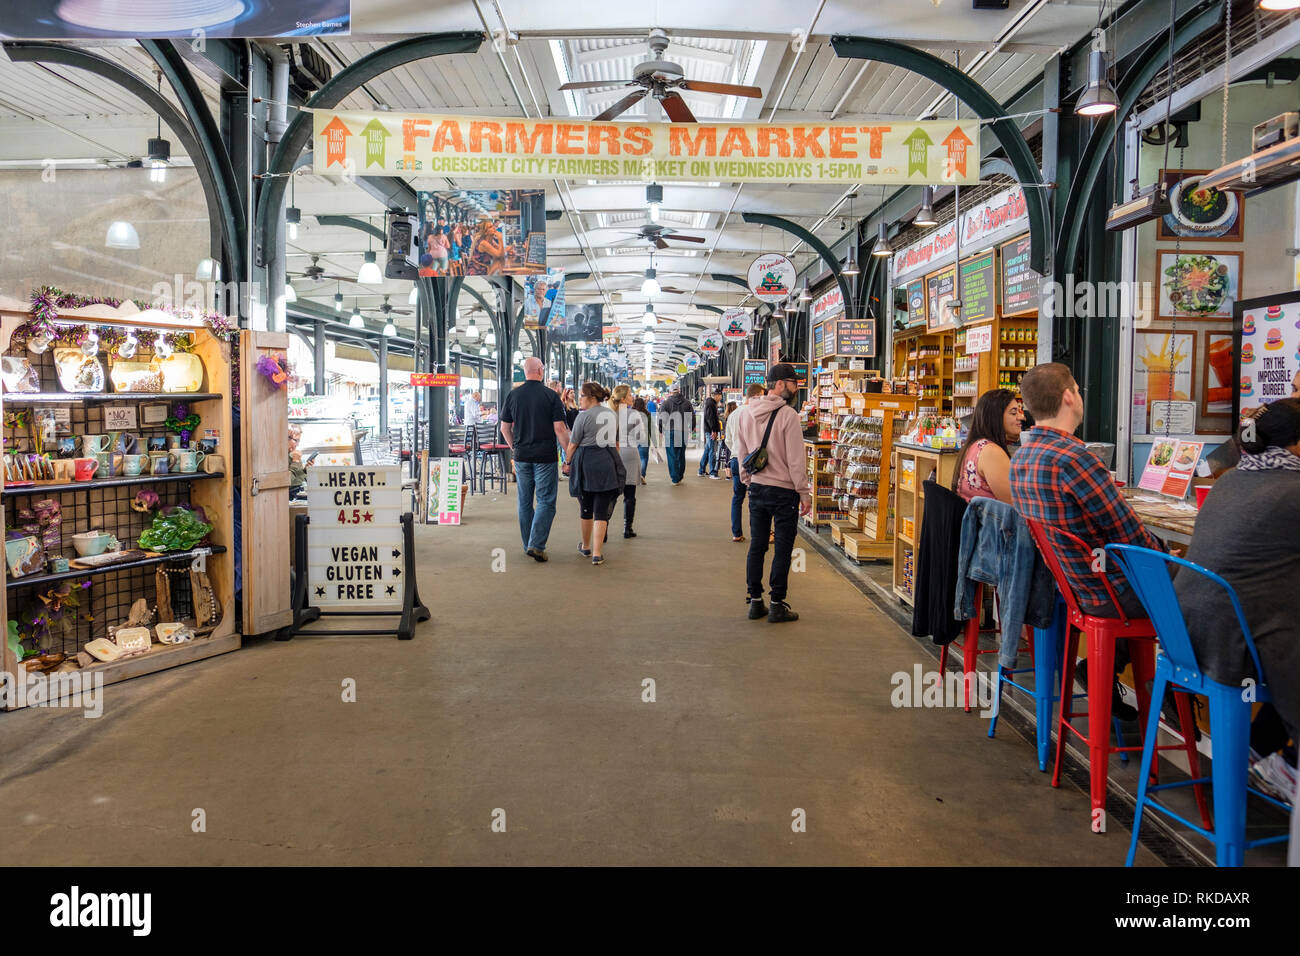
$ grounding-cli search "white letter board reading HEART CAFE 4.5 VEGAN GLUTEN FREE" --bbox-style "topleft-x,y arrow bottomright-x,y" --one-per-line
307,464 -> 406,610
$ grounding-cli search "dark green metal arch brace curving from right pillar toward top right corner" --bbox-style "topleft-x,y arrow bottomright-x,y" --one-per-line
1056,5 -> 1223,272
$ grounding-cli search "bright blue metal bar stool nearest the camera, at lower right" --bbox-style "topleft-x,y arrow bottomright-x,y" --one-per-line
1106,545 -> 1291,866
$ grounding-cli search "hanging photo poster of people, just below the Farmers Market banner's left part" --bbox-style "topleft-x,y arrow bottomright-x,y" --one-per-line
419,189 -> 546,278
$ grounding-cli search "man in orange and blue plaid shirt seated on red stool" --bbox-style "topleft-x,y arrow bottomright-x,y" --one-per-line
1011,362 -> 1165,618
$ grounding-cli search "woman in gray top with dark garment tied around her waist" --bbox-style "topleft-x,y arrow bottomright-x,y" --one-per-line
564,381 -> 627,564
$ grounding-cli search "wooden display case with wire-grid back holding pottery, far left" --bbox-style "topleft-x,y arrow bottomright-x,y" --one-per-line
0,298 -> 241,709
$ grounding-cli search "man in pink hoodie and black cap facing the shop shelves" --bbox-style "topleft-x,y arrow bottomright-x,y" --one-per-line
733,362 -> 813,624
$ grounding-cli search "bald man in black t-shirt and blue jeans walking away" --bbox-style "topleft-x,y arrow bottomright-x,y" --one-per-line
501,355 -> 569,561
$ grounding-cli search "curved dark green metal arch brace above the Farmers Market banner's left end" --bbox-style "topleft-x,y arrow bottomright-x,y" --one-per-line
256,33 -> 486,265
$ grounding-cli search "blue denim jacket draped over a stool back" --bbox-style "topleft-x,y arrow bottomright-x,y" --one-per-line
953,497 -> 1056,667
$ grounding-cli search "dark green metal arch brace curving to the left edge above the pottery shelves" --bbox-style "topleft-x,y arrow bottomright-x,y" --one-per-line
4,43 -> 243,286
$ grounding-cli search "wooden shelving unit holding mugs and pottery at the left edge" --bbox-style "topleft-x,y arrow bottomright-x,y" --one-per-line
0,298 -> 239,706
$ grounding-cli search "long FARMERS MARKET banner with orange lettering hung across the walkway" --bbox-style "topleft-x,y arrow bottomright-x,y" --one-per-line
312,111 -> 980,185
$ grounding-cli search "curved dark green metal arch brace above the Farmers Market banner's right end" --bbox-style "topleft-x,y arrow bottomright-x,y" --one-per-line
831,36 -> 1050,274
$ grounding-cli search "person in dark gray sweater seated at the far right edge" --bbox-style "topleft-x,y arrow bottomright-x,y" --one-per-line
1174,398 -> 1300,740
